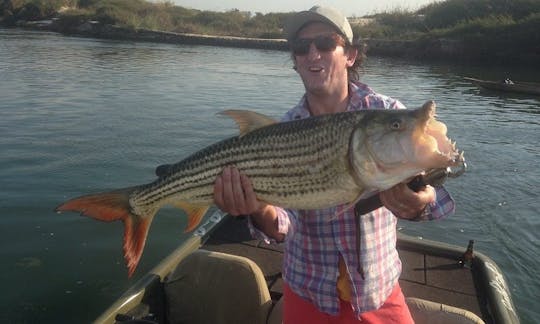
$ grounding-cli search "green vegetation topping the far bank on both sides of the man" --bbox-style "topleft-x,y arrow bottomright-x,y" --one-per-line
4,0 -> 540,39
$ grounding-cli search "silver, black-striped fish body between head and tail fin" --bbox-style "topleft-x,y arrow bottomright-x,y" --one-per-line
131,112 -> 365,213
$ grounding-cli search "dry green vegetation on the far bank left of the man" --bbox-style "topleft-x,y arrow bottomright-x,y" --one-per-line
0,0 -> 288,38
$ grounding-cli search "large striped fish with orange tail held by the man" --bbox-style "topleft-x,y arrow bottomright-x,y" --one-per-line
56,101 -> 462,276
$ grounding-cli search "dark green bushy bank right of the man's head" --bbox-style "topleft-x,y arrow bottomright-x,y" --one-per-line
353,0 -> 540,65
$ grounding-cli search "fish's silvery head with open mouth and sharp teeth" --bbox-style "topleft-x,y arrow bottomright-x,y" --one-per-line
349,101 -> 463,190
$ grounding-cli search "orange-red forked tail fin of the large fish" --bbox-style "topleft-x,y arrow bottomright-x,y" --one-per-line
55,187 -> 159,277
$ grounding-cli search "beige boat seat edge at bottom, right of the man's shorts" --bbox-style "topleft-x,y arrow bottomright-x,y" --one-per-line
405,297 -> 485,324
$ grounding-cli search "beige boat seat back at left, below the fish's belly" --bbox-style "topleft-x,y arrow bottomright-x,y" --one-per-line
164,249 -> 272,324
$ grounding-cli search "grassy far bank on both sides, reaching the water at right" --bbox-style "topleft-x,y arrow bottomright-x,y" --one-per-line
0,0 -> 540,65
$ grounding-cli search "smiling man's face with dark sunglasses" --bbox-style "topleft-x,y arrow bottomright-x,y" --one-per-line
293,22 -> 356,95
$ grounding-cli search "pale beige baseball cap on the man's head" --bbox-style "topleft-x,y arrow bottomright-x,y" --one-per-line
285,6 -> 353,44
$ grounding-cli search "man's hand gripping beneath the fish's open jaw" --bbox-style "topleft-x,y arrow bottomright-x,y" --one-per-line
379,183 -> 436,219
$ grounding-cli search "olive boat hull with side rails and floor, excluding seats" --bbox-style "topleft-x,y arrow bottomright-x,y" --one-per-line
96,211 -> 519,324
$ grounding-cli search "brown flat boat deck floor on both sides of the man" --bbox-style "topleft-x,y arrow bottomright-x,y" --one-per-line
202,217 -> 480,320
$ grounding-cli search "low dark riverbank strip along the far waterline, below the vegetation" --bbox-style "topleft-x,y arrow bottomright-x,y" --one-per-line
5,19 -> 540,66
